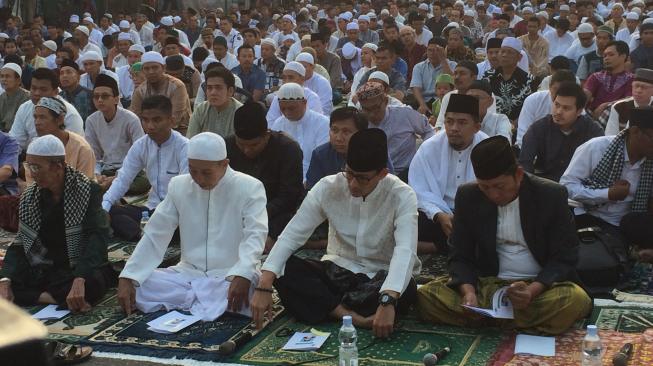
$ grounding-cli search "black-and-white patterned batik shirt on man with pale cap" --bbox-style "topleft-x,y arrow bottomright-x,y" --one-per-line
484,67 -> 535,121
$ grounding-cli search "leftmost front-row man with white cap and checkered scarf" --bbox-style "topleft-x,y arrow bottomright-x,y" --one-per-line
0,135 -> 115,312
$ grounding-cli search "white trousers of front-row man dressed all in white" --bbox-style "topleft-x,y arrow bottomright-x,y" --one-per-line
136,268 -> 254,321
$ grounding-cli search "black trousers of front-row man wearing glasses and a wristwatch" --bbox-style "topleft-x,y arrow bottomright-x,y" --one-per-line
274,256 -> 417,324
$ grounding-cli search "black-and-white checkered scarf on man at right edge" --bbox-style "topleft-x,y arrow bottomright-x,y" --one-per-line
581,129 -> 653,212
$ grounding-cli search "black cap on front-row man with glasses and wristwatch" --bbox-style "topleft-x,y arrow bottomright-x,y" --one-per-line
347,128 -> 388,172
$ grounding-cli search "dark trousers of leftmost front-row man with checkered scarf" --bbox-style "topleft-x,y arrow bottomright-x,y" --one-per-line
11,264 -> 118,307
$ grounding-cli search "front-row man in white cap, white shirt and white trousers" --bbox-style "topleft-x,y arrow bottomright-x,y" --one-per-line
118,132 -> 268,321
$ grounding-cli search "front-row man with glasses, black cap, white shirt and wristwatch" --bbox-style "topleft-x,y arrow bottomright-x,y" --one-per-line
252,128 -> 421,337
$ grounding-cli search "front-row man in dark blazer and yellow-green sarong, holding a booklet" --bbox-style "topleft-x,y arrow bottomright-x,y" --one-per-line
417,136 -> 592,334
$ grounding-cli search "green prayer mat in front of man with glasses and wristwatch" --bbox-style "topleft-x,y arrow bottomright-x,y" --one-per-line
231,316 -> 503,366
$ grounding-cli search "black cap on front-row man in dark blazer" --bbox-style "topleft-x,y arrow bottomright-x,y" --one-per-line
471,136 -> 517,180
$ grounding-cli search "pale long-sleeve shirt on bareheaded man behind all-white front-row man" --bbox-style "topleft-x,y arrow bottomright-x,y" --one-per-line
102,131 -> 188,212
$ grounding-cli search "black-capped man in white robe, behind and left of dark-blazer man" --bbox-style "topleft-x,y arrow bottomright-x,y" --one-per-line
408,94 -> 488,252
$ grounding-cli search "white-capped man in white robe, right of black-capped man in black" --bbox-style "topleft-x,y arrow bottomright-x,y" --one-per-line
270,83 -> 329,180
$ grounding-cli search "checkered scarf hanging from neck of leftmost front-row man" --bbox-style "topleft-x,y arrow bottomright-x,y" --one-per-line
14,166 -> 91,267
